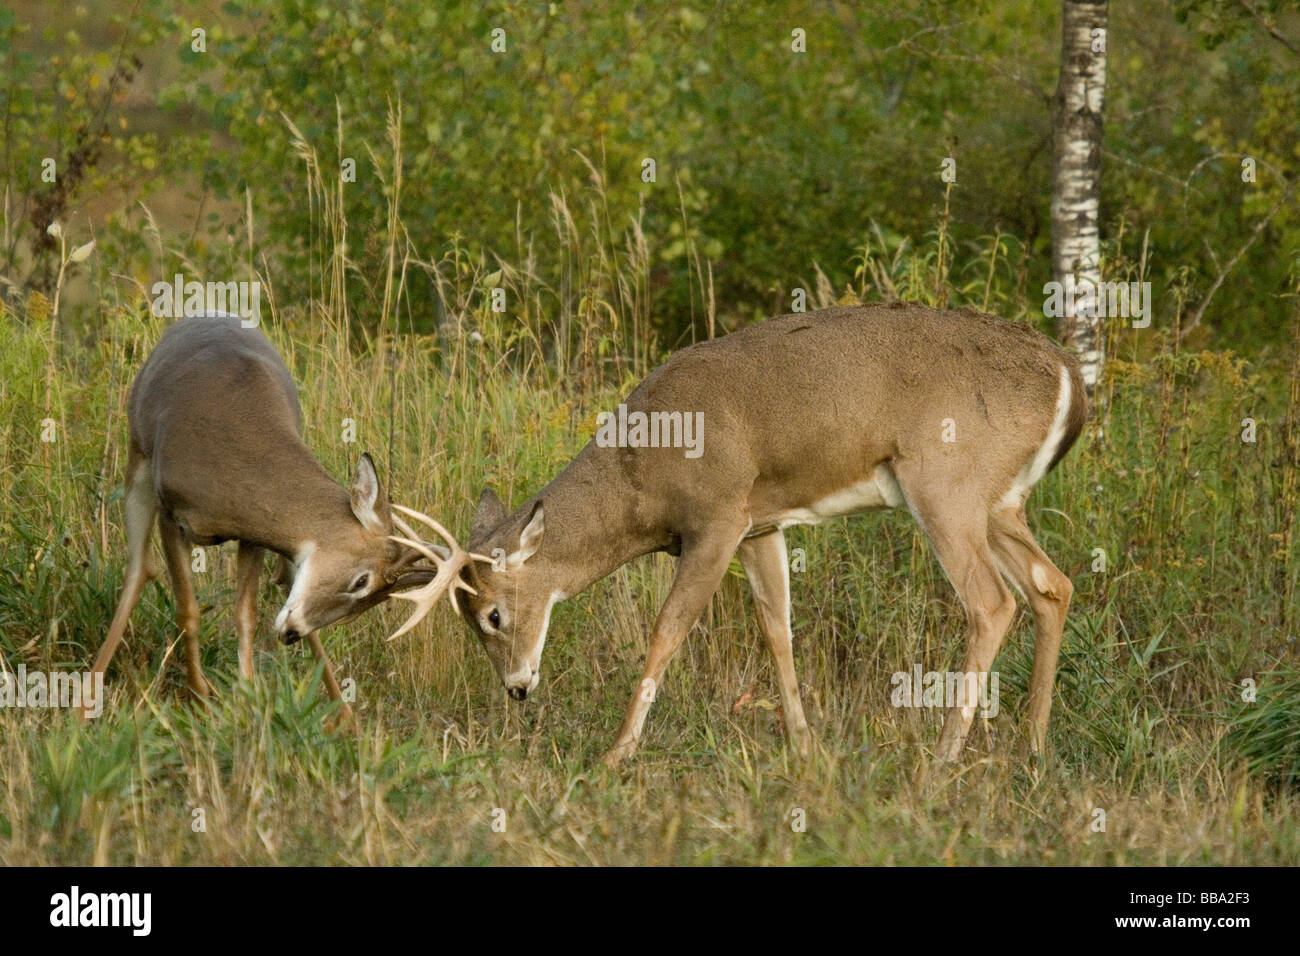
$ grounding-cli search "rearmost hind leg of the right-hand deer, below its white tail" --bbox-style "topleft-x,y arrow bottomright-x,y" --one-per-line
989,507 -> 1074,753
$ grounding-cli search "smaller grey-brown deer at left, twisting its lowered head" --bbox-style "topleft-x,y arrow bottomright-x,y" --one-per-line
94,315 -> 429,718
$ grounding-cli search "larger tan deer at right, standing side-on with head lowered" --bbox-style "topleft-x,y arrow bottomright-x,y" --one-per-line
394,303 -> 1088,765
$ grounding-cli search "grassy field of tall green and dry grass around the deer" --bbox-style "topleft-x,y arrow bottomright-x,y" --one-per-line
0,201 -> 1300,865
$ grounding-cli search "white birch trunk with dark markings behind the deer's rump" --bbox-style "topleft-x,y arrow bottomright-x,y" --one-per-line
1052,0 -> 1106,392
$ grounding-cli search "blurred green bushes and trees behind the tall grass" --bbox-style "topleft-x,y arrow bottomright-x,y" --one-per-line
0,0 -> 1300,354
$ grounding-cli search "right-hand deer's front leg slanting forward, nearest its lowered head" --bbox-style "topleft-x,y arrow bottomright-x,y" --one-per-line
601,528 -> 744,767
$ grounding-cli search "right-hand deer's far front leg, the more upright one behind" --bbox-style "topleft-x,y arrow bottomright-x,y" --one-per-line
737,531 -> 813,757
